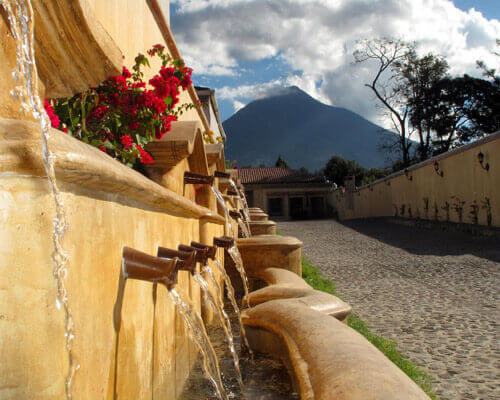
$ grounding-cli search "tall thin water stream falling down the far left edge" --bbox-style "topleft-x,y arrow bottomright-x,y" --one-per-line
0,0 -> 79,399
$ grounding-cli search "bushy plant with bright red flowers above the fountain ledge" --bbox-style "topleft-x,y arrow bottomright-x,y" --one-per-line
45,45 -> 194,168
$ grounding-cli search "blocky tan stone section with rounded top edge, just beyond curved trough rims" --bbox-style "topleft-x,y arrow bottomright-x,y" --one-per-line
236,235 -> 302,276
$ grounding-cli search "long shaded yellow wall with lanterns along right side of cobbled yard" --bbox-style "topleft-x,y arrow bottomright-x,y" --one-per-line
331,133 -> 500,226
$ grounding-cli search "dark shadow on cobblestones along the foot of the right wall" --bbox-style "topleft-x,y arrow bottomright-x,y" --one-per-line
339,219 -> 500,262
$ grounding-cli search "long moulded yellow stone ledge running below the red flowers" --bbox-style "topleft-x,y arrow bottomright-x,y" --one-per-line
0,119 -> 225,225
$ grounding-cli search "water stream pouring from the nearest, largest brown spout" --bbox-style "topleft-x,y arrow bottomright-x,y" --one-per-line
168,288 -> 228,400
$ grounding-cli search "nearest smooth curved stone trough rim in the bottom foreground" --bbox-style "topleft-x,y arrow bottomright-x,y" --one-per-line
243,299 -> 428,400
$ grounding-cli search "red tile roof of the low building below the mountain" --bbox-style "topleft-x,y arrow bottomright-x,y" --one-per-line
238,167 -> 327,185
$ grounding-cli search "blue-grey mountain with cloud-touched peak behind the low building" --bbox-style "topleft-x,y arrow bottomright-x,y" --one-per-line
223,86 -> 394,171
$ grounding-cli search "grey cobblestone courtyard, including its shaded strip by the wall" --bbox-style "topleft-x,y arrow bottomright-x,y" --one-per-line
278,220 -> 500,400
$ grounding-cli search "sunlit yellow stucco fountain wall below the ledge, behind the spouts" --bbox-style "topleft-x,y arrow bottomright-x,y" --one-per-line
0,142 -> 224,399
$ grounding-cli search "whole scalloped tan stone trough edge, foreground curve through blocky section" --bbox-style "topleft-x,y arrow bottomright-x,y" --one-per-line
232,222 -> 428,400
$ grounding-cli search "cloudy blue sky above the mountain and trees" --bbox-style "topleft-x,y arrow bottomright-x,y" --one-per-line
171,0 -> 500,126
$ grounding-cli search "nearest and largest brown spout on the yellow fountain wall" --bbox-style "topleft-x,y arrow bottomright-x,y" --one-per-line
122,247 -> 179,290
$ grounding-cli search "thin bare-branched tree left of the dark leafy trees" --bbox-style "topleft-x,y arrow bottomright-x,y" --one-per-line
354,38 -> 415,166
